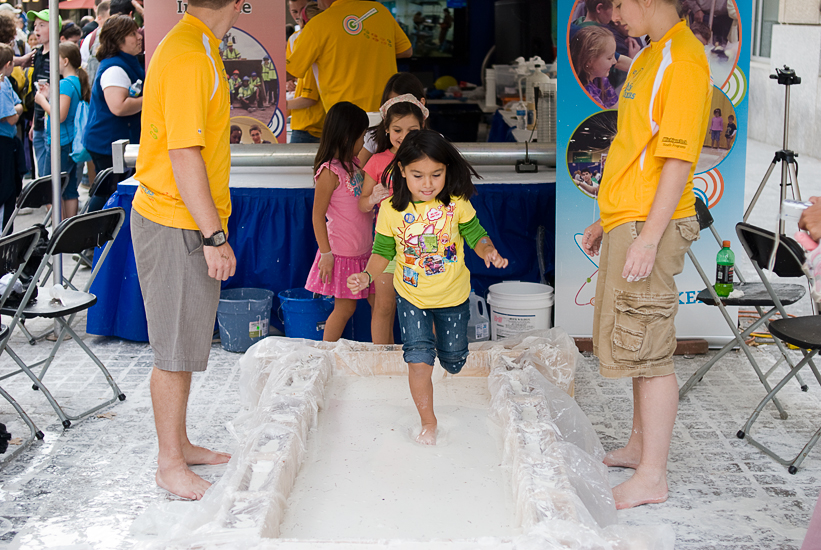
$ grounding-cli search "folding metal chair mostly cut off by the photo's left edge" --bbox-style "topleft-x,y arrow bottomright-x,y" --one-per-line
0,227 -> 48,466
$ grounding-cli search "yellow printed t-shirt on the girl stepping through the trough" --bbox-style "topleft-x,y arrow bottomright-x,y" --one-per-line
376,199 -> 476,309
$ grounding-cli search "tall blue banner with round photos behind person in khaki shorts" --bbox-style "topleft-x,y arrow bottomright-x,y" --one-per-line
555,0 -> 752,345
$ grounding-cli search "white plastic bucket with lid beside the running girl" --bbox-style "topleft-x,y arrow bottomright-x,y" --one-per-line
487,281 -> 553,340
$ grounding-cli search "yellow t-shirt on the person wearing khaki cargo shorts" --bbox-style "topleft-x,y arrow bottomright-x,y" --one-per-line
598,21 -> 713,232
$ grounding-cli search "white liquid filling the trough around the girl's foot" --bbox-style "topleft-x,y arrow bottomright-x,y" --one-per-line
280,378 -> 518,540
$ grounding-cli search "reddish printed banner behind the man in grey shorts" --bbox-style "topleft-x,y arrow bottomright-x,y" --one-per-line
145,0 -> 286,144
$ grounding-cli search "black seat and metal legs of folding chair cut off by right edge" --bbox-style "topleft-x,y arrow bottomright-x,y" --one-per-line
736,315 -> 821,474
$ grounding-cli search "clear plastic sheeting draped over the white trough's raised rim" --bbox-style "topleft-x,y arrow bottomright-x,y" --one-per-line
132,328 -> 674,550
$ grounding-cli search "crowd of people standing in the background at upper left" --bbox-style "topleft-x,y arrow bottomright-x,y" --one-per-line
0,0 -> 145,221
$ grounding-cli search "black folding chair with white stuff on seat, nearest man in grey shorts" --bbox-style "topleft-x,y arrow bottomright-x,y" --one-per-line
0,208 -> 125,428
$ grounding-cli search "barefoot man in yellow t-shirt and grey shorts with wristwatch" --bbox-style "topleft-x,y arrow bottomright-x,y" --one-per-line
131,0 -> 242,500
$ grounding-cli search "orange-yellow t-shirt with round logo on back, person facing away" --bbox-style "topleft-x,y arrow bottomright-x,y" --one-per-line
286,0 -> 411,112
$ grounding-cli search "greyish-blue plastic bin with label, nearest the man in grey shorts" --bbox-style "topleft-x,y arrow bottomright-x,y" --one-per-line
217,288 -> 274,353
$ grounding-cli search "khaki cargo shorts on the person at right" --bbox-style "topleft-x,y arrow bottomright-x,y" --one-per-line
593,216 -> 699,378
